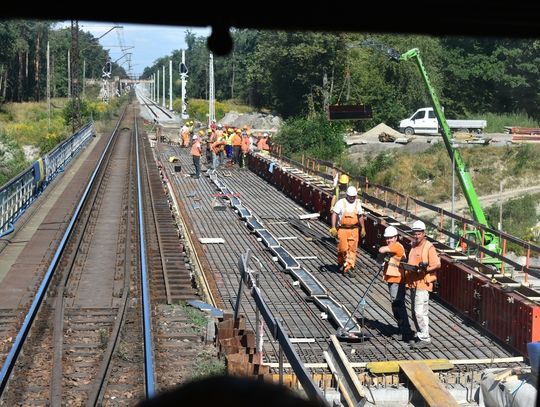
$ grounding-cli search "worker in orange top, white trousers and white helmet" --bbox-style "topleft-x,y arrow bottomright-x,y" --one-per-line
407,220 -> 441,349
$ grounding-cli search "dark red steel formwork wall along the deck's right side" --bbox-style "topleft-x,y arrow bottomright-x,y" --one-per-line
248,154 -> 540,356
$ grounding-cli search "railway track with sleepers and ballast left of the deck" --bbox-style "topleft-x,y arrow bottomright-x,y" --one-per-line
0,98 -> 207,405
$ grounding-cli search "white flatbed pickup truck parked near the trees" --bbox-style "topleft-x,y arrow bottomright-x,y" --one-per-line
399,107 -> 487,136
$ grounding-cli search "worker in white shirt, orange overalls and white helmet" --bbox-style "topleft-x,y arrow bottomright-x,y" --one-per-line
329,186 -> 366,274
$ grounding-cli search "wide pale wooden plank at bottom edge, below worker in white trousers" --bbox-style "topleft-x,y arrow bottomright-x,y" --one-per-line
399,362 -> 459,407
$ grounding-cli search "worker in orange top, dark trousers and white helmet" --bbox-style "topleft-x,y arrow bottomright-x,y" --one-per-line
379,226 -> 414,342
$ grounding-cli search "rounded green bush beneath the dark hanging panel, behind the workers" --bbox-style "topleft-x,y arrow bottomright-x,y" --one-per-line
274,114 -> 345,160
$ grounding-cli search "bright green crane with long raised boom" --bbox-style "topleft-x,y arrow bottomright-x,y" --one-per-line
400,48 -> 501,267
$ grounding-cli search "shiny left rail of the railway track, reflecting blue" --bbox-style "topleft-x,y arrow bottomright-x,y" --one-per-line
0,109 -> 125,395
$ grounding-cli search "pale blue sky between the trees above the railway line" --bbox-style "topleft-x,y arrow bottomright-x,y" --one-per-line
58,21 -> 211,76
